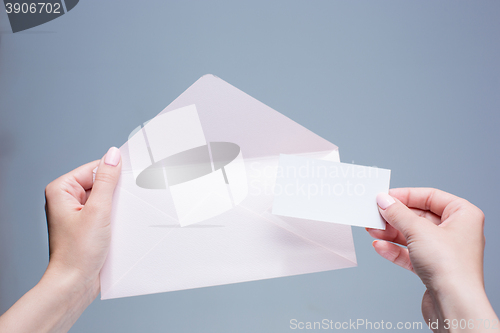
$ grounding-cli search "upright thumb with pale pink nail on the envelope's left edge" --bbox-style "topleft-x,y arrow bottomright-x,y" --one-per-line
84,147 -> 122,219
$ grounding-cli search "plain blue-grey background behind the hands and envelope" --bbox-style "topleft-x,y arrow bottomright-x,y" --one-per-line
0,0 -> 500,332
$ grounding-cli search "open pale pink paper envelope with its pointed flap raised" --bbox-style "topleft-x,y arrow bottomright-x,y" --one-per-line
101,75 -> 356,299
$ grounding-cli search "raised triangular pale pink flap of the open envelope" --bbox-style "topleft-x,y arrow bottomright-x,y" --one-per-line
156,74 -> 338,159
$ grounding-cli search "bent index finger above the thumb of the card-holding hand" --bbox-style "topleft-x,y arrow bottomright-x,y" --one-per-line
389,188 -> 459,216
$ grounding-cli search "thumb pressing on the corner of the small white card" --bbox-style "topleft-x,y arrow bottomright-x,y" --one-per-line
377,193 -> 432,240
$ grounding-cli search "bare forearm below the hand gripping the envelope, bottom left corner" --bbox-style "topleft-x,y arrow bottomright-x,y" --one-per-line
0,265 -> 98,333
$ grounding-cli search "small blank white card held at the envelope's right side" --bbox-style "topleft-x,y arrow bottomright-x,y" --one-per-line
272,155 -> 391,229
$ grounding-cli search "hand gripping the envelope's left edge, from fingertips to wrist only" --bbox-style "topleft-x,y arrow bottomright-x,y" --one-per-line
45,147 -> 121,298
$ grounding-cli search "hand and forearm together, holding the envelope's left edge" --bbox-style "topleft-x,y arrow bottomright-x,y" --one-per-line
0,147 -> 121,332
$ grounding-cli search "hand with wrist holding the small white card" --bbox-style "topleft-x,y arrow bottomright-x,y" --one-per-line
367,188 -> 500,332
